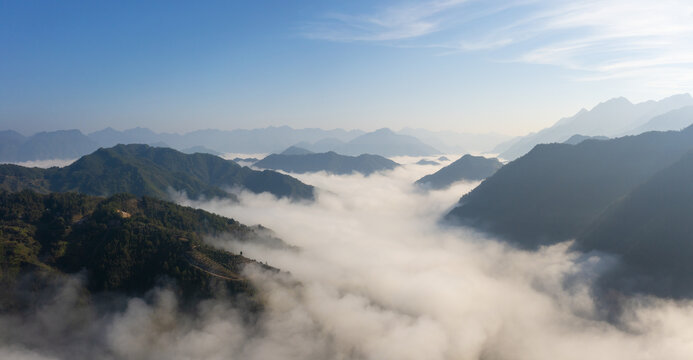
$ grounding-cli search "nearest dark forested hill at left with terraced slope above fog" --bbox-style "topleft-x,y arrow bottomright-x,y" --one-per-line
0,191 -> 283,309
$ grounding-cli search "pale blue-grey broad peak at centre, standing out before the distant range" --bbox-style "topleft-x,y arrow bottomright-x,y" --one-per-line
334,129 -> 440,156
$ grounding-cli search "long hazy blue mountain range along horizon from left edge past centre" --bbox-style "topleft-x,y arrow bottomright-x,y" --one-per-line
0,126 -> 440,162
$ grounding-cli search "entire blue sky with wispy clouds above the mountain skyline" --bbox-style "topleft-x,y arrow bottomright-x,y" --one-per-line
0,0 -> 693,134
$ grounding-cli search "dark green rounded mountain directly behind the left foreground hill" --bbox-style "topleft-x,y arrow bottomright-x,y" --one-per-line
0,145 -> 313,200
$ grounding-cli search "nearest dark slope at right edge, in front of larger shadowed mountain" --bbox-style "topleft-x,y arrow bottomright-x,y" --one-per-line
576,153 -> 693,297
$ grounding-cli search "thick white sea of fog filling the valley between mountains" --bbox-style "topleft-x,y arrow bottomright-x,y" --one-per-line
0,158 -> 693,359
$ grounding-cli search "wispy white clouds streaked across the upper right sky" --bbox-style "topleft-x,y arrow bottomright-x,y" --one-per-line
305,0 -> 693,89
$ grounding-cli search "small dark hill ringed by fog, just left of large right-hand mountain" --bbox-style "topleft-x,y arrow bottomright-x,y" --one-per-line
416,155 -> 503,189
